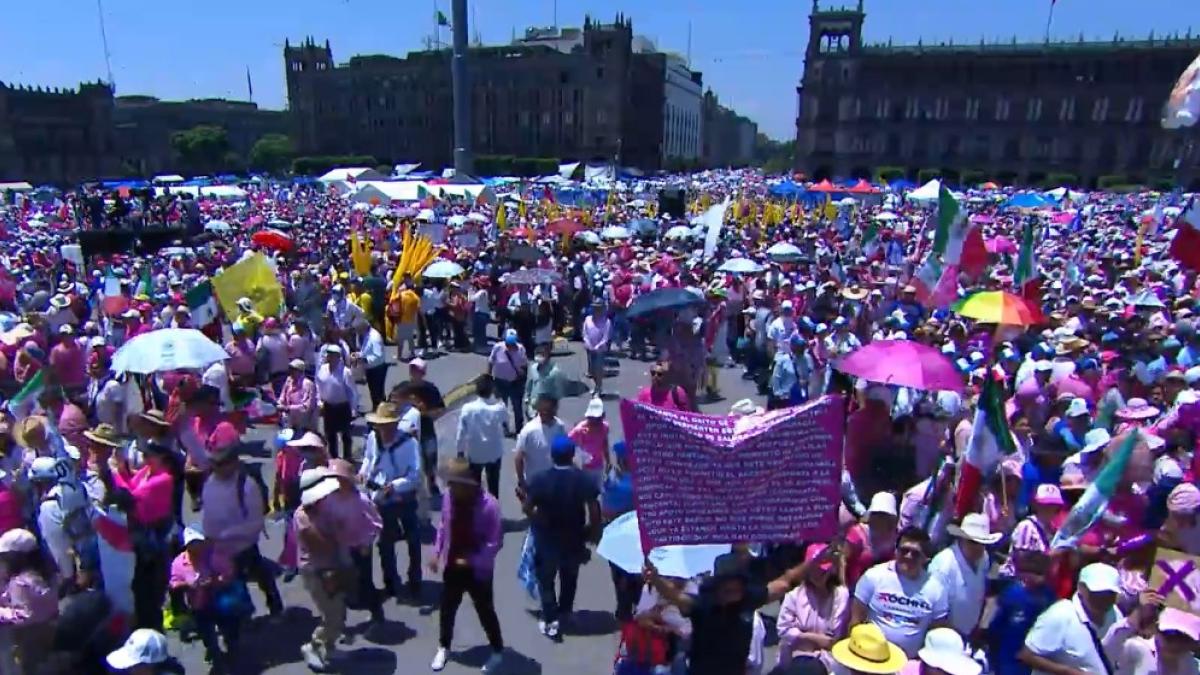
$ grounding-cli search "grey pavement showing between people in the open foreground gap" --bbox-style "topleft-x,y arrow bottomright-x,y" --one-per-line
172,345 -> 752,675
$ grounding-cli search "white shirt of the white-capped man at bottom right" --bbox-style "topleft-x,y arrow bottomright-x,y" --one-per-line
1025,596 -> 1121,675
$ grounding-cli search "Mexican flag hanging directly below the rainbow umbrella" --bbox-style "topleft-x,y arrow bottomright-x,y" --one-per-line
954,375 -> 1016,518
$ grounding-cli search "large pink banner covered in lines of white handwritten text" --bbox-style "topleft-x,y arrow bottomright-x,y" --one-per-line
620,396 -> 845,550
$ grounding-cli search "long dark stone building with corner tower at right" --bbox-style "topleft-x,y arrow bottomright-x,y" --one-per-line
796,0 -> 1200,187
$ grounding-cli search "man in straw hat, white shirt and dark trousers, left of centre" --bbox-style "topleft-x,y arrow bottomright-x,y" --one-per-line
359,402 -> 421,599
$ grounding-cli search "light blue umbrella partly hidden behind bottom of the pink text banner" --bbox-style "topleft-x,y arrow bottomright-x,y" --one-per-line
596,512 -> 732,579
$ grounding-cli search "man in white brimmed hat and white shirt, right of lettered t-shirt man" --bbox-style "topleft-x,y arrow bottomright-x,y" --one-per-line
929,513 -> 1001,639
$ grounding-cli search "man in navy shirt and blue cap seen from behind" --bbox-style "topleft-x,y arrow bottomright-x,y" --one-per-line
524,436 -> 600,640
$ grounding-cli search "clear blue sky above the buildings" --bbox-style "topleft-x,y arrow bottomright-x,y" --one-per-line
0,0 -> 1200,138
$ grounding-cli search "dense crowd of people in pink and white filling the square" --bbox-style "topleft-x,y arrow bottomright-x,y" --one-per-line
0,171 -> 1200,675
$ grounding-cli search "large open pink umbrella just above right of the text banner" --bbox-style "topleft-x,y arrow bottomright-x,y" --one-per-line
834,340 -> 962,392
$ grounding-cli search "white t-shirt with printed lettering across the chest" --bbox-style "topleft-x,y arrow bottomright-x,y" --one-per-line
854,562 -> 950,658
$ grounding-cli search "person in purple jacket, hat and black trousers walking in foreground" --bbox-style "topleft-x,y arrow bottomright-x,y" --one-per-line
428,458 -> 504,673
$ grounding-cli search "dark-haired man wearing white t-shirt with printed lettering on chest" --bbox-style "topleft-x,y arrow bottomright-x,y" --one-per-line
850,527 -> 950,658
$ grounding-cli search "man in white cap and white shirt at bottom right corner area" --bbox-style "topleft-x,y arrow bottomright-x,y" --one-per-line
1016,562 -> 1122,675
